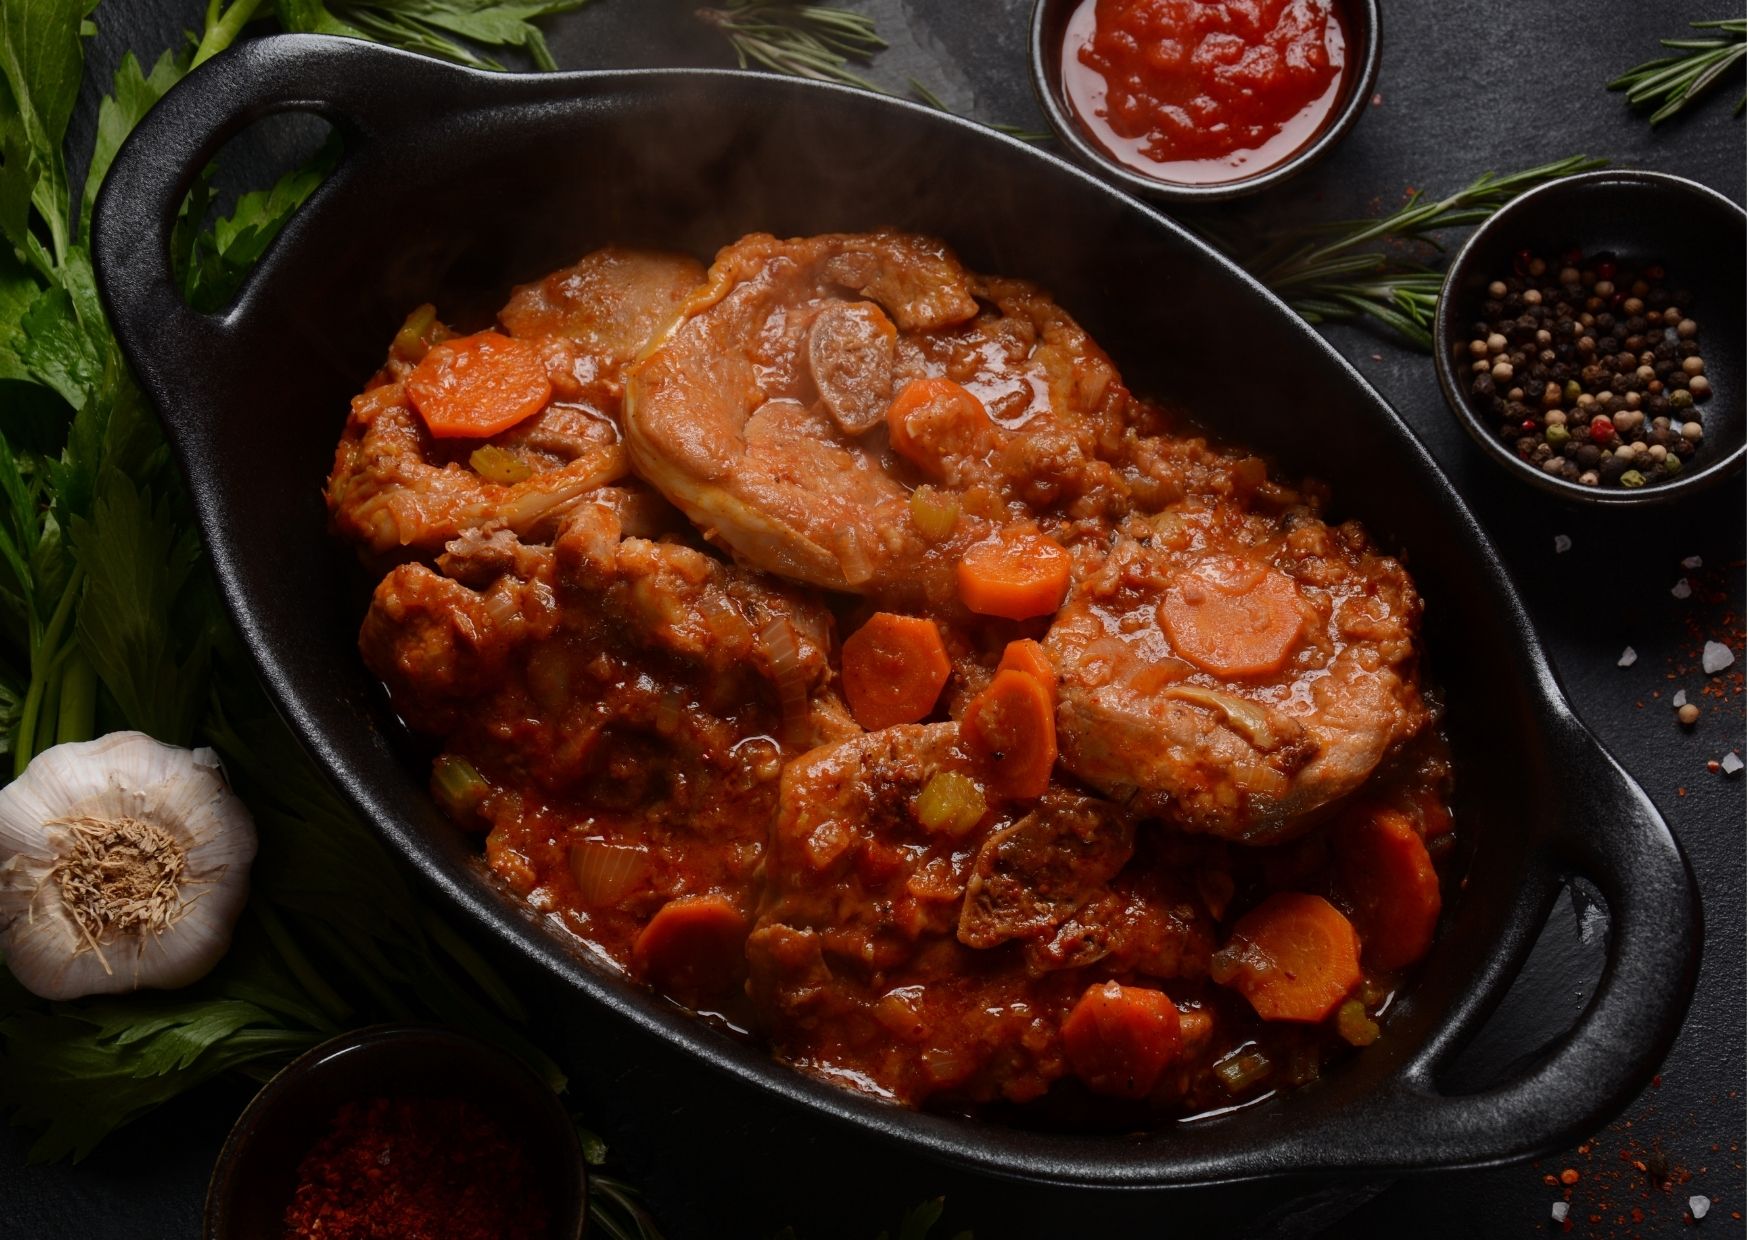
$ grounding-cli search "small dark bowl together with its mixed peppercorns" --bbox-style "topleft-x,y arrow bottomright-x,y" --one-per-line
1433,171 -> 1748,504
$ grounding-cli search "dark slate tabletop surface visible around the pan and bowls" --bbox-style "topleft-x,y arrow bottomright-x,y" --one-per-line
0,0 -> 1748,1240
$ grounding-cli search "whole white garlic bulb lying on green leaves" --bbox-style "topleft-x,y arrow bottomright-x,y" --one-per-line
0,733 -> 255,999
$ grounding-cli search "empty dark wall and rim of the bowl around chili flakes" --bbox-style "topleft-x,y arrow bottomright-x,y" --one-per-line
201,1025 -> 587,1240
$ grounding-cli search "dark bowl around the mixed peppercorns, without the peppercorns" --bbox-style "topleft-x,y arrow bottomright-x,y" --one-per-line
1433,170 -> 1748,505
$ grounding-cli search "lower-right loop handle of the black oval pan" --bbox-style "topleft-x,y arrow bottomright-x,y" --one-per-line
1349,712 -> 1701,1170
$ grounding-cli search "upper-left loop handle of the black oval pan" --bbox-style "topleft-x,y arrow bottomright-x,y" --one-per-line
93,35 -> 484,390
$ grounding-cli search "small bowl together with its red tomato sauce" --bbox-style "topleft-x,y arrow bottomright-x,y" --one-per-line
1031,0 -> 1383,201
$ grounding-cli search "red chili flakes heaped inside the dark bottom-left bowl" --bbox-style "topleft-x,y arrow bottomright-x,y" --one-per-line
285,1098 -> 549,1240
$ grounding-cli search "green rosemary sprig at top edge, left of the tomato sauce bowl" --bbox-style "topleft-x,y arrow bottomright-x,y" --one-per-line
697,0 -> 886,94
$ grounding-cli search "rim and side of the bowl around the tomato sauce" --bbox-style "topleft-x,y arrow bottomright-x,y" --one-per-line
1031,0 -> 1384,203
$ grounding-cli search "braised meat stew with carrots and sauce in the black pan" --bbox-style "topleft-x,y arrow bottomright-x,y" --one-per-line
327,233 -> 1453,1121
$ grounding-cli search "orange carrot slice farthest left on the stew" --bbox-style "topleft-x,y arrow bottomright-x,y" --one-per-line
407,332 -> 552,439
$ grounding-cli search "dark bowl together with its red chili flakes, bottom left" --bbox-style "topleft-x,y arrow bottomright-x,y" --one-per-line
205,1027 -> 586,1240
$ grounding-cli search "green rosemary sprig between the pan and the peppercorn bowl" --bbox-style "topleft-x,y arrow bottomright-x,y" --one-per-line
1204,156 -> 1606,352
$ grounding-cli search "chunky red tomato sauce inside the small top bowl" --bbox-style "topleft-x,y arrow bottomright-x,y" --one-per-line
1063,0 -> 1348,184
